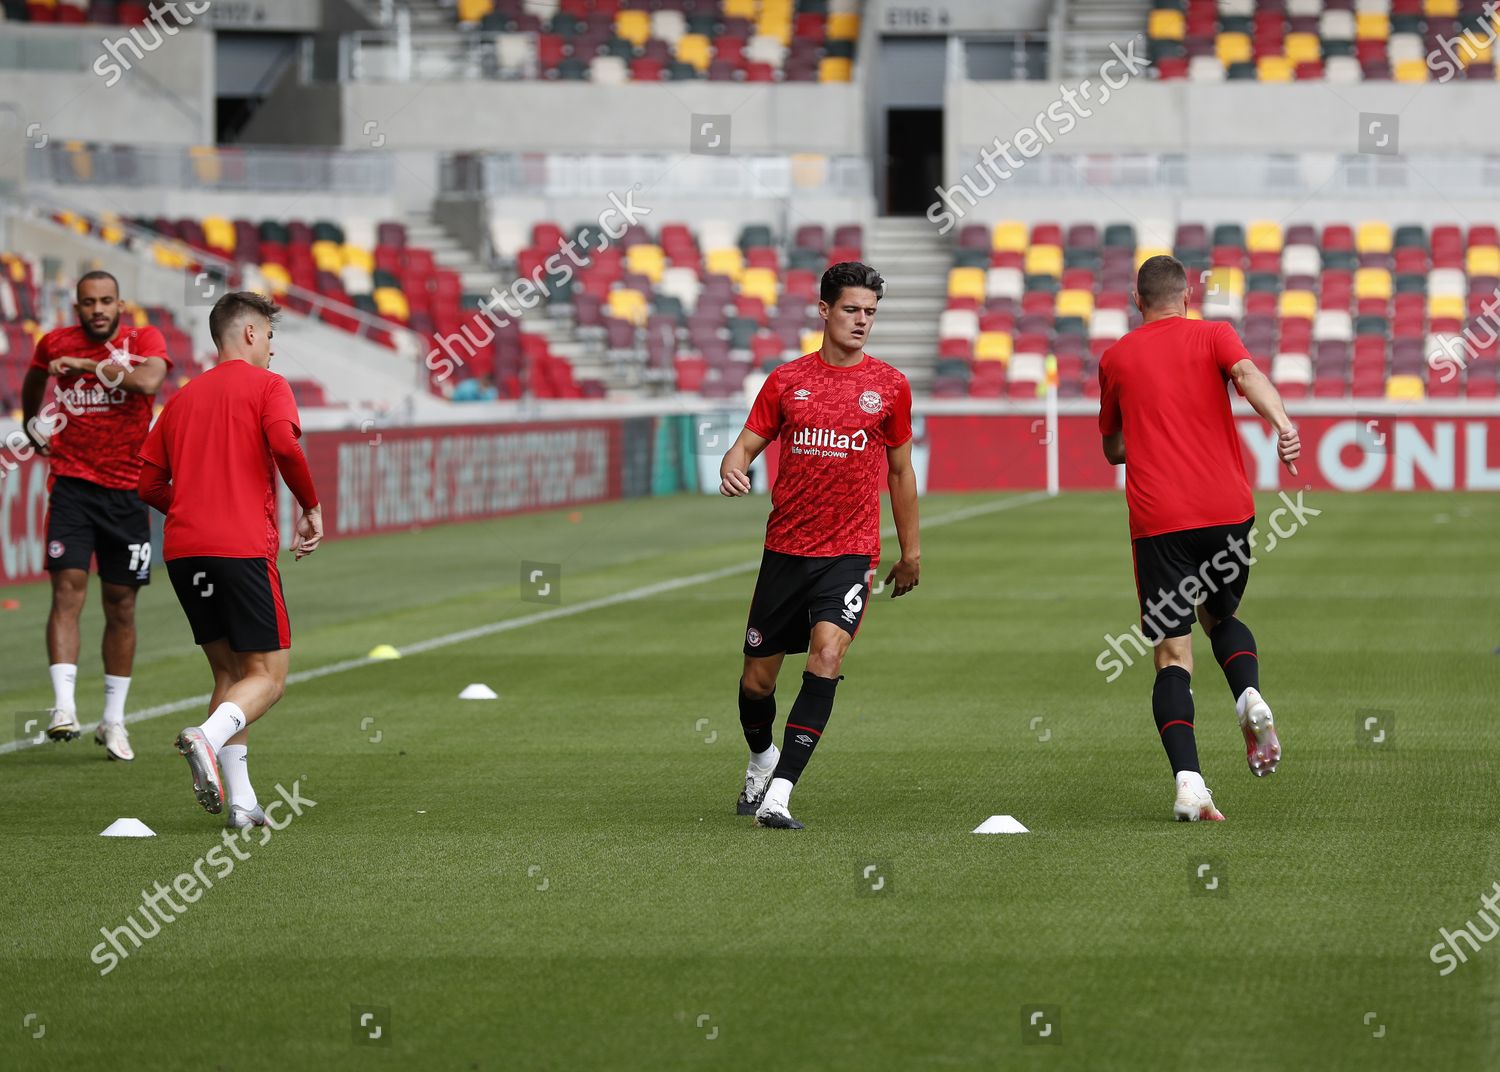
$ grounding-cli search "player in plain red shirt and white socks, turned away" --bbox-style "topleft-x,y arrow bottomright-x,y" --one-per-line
140,291 -> 323,828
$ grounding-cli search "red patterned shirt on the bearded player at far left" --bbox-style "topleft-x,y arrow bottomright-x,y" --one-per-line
32,322 -> 173,490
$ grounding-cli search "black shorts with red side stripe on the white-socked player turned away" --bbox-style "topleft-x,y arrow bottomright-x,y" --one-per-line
167,556 -> 291,651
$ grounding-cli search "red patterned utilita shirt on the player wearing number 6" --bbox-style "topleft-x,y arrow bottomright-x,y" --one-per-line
746,352 -> 912,559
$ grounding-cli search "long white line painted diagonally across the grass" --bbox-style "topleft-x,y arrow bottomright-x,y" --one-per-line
0,492 -> 1049,756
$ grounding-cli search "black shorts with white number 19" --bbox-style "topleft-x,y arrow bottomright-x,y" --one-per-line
47,477 -> 152,588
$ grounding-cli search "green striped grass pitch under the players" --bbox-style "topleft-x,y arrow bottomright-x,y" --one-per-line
0,493 -> 1500,1069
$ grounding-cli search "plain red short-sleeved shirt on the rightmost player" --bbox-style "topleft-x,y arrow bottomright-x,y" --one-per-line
1100,316 -> 1256,540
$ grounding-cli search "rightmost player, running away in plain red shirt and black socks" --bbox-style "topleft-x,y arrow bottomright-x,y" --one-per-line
1100,256 -> 1302,822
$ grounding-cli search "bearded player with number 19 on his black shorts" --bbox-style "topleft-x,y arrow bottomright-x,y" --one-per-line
21,271 -> 173,760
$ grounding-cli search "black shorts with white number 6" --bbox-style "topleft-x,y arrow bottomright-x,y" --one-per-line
746,550 -> 879,658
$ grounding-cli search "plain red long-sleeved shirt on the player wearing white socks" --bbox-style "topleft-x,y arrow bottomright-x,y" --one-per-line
141,360 -> 317,561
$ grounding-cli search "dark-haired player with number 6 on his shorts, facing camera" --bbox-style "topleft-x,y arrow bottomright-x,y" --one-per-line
719,261 -> 921,829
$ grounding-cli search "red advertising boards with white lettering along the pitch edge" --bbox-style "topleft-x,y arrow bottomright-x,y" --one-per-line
0,403 -> 1500,585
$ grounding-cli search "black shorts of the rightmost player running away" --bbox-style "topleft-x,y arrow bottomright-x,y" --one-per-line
1133,517 -> 1256,642
